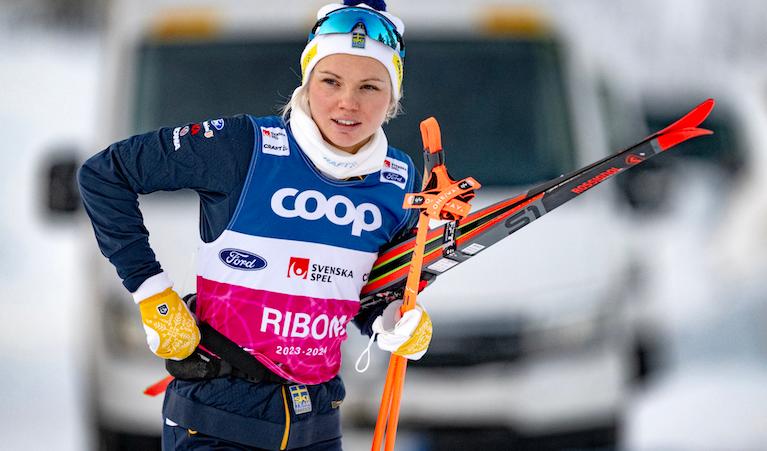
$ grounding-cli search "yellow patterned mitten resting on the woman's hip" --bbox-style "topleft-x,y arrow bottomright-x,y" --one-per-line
139,288 -> 200,360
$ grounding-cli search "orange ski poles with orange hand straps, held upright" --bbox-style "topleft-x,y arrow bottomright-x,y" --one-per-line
372,117 -> 480,451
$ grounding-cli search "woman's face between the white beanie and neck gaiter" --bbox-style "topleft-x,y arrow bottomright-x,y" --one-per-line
309,54 -> 392,154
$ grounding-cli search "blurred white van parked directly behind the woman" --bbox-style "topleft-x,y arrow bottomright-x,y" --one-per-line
43,1 -> 640,449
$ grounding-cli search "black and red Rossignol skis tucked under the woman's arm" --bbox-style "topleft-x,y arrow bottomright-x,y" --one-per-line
360,99 -> 714,309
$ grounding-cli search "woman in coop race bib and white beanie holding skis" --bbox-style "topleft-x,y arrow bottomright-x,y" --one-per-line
79,1 -> 431,450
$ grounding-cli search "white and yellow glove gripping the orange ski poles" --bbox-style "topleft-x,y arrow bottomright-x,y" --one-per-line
373,301 -> 432,360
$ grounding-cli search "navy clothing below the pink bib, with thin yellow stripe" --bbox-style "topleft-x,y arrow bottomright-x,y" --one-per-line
163,376 -> 346,451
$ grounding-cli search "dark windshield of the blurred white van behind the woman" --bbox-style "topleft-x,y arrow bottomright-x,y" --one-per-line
133,38 -> 575,186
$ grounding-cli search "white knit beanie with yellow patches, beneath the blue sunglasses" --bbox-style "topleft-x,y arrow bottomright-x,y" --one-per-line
301,0 -> 405,101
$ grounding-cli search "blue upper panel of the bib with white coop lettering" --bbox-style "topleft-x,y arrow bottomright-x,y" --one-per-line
229,116 -> 415,252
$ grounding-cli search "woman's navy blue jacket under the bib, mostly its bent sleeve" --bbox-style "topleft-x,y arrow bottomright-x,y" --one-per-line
78,115 -> 420,335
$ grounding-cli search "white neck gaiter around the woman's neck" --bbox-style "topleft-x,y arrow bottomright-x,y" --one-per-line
289,87 -> 389,180
